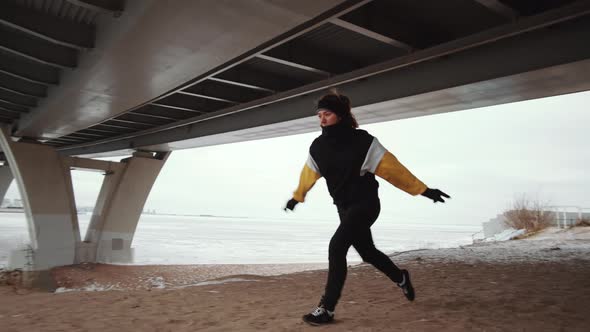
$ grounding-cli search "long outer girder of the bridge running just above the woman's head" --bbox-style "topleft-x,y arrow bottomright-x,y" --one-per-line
58,0 -> 590,154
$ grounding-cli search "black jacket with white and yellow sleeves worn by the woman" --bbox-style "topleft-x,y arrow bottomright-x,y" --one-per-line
293,122 -> 426,205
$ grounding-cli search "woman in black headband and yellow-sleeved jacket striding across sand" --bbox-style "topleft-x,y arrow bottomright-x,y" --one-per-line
285,92 -> 450,325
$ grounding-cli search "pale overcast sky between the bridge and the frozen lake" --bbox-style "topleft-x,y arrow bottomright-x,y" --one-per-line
7,92 -> 590,224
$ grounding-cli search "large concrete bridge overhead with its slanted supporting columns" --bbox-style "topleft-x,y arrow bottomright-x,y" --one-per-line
0,0 -> 590,278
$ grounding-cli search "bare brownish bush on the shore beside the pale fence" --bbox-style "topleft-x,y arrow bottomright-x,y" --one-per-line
504,195 -> 554,233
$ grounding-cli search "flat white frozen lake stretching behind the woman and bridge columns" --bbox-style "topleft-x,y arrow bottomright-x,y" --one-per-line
0,213 -> 481,266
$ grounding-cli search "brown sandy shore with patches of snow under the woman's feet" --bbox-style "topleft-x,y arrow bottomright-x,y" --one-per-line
0,228 -> 590,331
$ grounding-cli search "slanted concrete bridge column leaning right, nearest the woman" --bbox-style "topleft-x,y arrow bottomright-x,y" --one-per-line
78,152 -> 170,263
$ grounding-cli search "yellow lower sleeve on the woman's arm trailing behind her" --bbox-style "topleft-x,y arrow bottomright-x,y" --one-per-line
375,151 -> 426,195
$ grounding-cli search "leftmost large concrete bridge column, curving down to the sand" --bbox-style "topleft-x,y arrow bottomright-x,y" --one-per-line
0,127 -> 80,271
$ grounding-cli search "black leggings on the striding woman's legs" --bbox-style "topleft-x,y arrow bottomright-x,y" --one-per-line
323,200 -> 402,311
